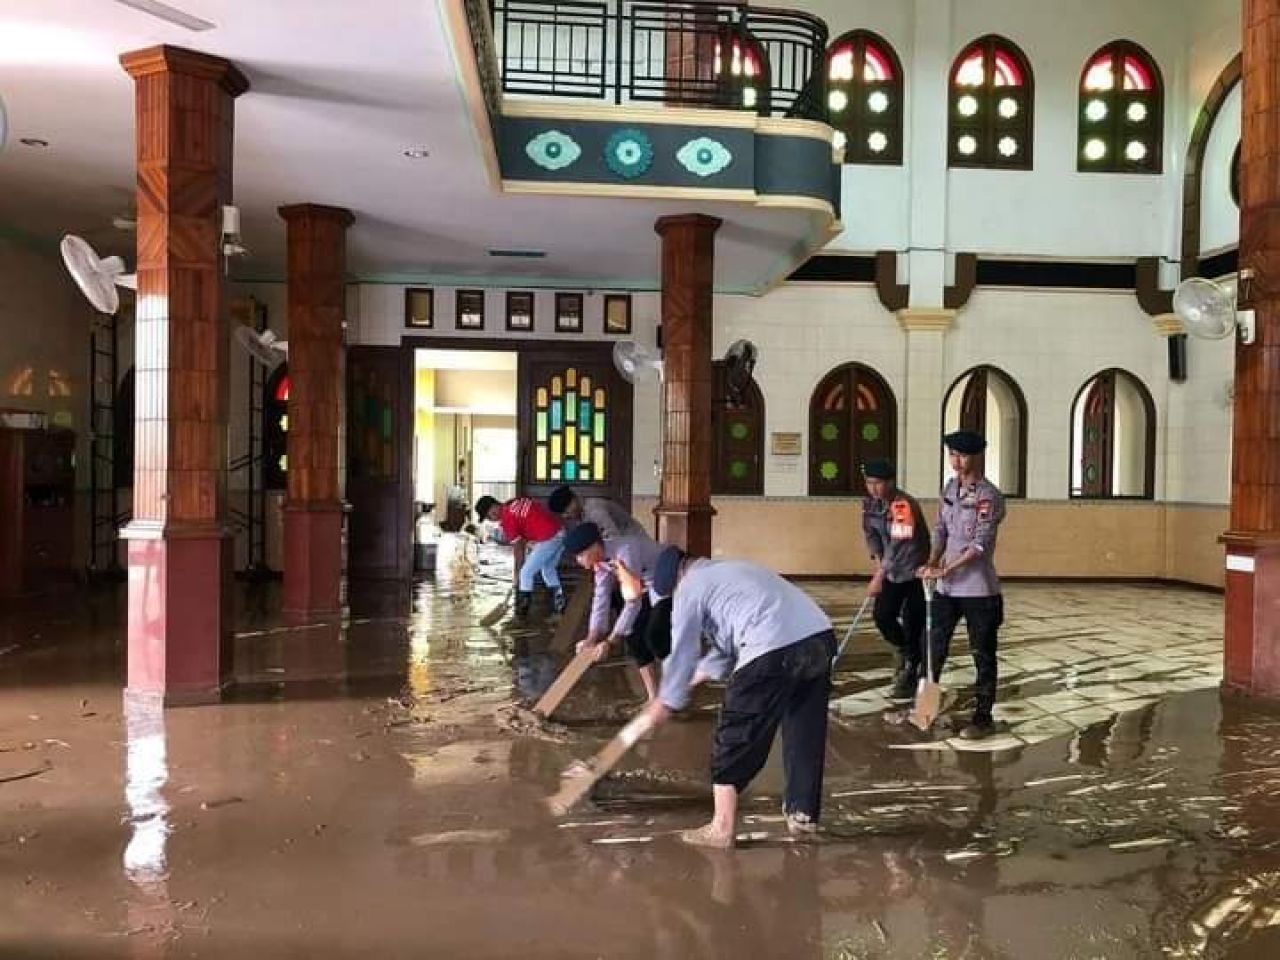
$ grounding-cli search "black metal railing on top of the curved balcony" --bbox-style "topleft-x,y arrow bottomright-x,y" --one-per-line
490,0 -> 827,120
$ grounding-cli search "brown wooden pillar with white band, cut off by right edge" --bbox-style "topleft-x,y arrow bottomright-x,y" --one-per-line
1222,0 -> 1280,698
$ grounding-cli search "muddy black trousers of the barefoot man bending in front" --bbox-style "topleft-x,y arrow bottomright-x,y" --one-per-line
712,630 -> 836,820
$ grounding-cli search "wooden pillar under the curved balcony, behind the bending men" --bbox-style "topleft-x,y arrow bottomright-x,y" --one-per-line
654,214 -> 721,557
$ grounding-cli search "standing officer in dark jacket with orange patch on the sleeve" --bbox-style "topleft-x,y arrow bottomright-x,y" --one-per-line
863,460 -> 929,700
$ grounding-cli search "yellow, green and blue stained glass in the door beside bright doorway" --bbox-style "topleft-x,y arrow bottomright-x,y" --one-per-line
534,366 -> 609,484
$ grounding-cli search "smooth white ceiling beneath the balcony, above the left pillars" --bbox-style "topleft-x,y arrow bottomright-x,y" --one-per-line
0,0 -> 818,289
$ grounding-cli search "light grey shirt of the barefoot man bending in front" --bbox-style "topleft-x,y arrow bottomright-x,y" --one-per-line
658,559 -> 831,710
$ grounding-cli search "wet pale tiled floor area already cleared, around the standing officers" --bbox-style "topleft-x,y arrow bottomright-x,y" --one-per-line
805,584 -> 1222,751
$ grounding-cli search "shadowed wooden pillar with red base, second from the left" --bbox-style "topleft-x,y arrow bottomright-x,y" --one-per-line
280,204 -> 355,614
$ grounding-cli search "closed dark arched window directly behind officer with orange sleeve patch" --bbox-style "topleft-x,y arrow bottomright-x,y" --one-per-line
809,364 -> 897,497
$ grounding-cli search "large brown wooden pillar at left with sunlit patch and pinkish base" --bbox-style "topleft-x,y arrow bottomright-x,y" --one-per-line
120,46 -> 248,704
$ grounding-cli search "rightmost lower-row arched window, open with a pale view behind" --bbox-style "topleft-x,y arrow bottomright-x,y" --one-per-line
1071,367 -> 1156,499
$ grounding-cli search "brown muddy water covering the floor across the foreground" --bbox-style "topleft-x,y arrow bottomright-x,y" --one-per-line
0,582 -> 1280,960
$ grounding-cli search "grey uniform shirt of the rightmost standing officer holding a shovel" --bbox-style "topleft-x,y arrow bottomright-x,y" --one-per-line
933,477 -> 1005,596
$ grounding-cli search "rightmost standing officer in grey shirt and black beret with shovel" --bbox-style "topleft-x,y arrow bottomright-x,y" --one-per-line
920,430 -> 1005,740
